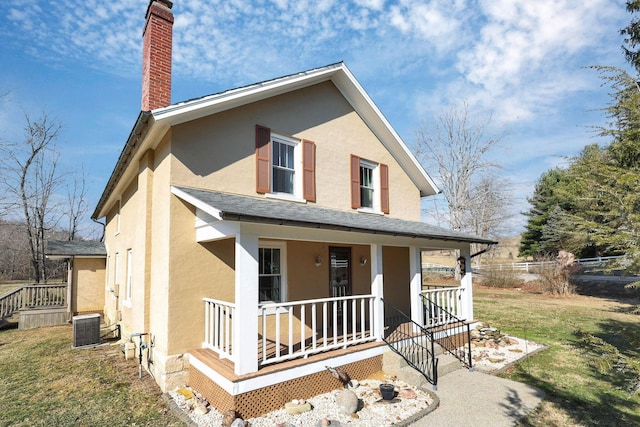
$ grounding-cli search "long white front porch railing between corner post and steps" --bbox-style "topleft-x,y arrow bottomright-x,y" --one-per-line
258,295 -> 376,365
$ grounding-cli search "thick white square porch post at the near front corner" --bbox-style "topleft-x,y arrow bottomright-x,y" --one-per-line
233,232 -> 259,375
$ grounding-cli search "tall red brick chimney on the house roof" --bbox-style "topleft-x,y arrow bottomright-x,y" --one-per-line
142,0 -> 173,111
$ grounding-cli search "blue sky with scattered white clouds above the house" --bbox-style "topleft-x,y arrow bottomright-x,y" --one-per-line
0,0 -> 631,236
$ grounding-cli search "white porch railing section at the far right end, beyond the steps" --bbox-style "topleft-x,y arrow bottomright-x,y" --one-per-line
420,287 -> 466,327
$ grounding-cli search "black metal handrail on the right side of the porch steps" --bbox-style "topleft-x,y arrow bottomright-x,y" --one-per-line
422,295 -> 473,369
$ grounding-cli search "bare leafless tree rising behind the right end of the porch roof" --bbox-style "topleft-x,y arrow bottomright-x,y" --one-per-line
416,103 -> 514,242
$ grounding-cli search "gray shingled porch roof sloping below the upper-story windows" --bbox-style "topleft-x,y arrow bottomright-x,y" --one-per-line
175,186 -> 496,244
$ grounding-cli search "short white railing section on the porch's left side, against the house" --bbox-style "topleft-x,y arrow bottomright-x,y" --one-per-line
203,298 -> 236,362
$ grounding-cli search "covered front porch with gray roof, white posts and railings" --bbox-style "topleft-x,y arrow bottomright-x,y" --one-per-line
172,187 -> 490,416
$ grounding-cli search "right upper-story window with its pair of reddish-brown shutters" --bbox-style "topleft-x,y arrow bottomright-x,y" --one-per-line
351,155 -> 389,214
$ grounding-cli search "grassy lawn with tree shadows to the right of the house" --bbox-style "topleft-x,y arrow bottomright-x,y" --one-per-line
474,288 -> 640,426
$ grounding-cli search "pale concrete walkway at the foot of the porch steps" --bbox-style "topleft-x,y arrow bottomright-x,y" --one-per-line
412,369 -> 545,427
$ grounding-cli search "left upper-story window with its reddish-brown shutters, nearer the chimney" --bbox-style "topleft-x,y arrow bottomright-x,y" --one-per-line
256,125 -> 316,202
